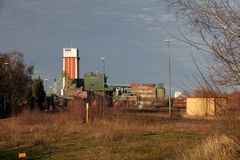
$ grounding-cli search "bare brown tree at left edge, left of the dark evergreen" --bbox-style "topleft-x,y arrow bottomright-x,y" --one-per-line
0,52 -> 33,113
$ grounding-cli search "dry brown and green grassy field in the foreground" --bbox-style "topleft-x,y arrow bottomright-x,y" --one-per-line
0,111 -> 234,160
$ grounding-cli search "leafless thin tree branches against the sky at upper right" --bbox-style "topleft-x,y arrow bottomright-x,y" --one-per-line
169,0 -> 240,86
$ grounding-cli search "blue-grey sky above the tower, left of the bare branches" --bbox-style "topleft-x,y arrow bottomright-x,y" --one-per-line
0,0 -> 200,93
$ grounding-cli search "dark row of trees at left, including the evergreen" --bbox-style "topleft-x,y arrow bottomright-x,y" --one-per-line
0,51 -> 45,115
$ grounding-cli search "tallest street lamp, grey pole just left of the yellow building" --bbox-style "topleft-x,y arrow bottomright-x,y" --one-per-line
163,39 -> 172,117
